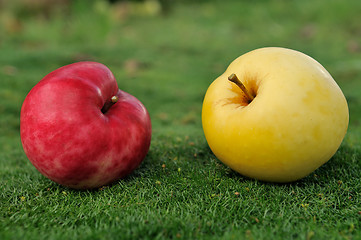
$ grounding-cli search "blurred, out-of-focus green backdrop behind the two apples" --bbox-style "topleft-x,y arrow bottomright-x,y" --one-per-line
0,0 -> 361,142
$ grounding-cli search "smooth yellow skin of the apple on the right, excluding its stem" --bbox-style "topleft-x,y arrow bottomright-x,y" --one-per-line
202,47 -> 349,182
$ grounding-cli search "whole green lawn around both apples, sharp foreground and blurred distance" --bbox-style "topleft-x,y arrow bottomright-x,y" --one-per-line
0,0 -> 361,239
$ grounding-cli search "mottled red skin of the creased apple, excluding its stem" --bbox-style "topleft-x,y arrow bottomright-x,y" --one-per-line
20,62 -> 151,189
